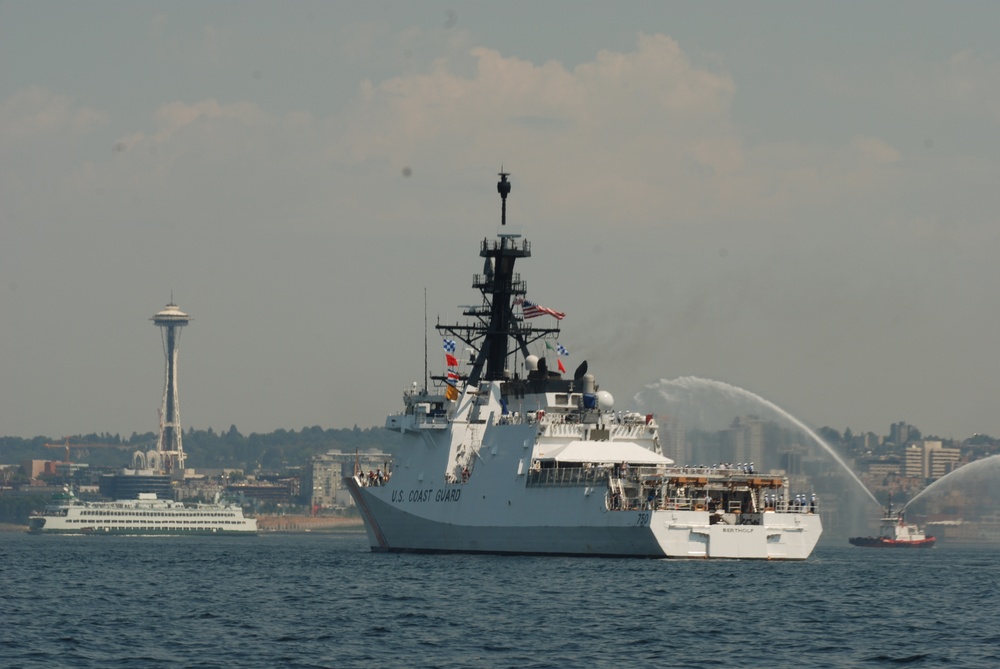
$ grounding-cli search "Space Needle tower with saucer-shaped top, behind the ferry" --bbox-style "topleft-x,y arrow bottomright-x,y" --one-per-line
149,300 -> 191,476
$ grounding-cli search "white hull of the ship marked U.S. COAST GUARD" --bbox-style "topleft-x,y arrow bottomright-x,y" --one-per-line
345,412 -> 822,560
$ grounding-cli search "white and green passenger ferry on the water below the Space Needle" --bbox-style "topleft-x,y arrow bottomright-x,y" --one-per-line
28,492 -> 257,535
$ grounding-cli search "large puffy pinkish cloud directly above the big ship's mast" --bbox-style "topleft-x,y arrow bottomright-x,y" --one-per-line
350,35 -> 744,224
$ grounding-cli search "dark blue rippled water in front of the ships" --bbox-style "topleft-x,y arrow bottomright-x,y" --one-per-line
0,532 -> 1000,669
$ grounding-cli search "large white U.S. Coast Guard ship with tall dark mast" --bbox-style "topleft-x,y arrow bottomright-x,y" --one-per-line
345,173 -> 822,560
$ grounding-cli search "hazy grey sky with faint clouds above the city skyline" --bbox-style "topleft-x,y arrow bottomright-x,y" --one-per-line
0,0 -> 1000,438
